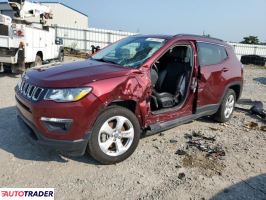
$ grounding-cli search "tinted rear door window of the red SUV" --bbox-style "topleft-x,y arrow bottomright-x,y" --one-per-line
198,42 -> 228,66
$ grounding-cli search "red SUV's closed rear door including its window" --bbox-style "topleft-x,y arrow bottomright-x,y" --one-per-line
197,42 -> 228,112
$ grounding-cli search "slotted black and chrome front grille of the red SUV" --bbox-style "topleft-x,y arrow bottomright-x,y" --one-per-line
18,80 -> 44,101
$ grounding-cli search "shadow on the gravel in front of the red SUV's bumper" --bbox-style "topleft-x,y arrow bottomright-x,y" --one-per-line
0,107 -> 99,165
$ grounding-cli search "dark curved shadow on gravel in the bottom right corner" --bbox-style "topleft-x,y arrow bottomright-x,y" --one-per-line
211,174 -> 266,200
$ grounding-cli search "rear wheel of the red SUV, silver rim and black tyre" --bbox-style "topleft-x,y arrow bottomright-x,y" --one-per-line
214,89 -> 236,123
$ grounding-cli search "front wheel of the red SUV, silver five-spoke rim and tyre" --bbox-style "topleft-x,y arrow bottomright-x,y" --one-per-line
87,106 -> 141,164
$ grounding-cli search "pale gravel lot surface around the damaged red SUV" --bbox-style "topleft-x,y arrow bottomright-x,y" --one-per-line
0,61 -> 266,200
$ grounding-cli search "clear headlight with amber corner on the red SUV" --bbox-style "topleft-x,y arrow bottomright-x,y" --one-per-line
44,87 -> 92,102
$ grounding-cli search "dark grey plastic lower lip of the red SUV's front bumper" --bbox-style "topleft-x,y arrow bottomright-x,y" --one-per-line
17,110 -> 90,156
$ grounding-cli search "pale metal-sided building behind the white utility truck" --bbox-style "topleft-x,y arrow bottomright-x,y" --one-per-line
0,2 -> 89,29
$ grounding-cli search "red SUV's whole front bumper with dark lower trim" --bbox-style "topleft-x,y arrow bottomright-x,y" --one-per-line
16,89 -> 102,156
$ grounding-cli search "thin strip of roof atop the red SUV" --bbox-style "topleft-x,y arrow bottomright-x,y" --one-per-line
136,34 -> 228,46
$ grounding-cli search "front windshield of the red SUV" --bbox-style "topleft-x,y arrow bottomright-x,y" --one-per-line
92,37 -> 165,68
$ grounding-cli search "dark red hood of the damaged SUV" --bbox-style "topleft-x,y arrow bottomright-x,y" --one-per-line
25,60 -> 130,88
